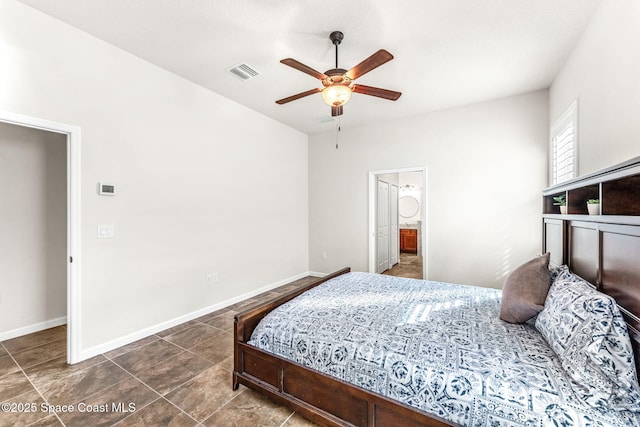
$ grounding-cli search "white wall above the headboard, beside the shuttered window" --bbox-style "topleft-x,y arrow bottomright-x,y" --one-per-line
549,0 -> 640,175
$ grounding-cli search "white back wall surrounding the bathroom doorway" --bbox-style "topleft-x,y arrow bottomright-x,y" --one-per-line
309,91 -> 548,287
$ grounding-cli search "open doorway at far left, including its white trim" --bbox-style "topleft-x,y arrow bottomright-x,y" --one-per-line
0,112 -> 80,363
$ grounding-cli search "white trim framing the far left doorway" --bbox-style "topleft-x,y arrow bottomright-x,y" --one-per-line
0,111 -> 82,364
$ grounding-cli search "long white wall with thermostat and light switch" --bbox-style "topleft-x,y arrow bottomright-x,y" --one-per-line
0,0 -> 308,355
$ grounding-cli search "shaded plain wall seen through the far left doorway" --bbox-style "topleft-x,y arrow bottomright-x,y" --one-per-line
0,122 -> 67,334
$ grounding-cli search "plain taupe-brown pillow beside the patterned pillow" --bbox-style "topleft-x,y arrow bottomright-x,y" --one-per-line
500,252 -> 551,323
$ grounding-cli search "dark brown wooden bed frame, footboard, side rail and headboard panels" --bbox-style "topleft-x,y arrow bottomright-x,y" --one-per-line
233,162 -> 640,427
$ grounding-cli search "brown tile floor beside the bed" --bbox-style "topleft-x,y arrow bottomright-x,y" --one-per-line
0,278 -> 314,427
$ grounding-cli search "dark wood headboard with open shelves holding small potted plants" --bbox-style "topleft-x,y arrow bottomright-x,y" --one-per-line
542,158 -> 640,375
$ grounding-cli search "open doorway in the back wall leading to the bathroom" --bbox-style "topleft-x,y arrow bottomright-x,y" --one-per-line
369,167 -> 428,279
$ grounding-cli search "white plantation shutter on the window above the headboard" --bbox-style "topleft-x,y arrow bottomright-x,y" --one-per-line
549,101 -> 578,185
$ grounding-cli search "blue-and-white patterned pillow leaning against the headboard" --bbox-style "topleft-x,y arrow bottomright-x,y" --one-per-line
536,268 -> 640,412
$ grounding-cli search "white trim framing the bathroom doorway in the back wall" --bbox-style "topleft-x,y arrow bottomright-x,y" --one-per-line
369,166 -> 429,280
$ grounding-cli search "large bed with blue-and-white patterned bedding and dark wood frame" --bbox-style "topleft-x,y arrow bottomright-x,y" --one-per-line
233,169 -> 640,426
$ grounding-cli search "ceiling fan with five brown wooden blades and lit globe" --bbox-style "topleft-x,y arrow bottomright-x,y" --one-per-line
276,31 -> 402,116
